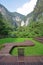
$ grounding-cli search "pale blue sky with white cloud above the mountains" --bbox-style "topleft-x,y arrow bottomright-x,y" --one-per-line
0,0 -> 37,15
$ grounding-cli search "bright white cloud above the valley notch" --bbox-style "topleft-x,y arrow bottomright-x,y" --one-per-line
17,0 -> 37,15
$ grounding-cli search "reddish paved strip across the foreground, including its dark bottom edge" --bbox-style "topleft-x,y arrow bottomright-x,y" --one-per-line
0,56 -> 43,65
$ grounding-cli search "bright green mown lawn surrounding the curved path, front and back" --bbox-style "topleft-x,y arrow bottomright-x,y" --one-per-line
0,38 -> 43,56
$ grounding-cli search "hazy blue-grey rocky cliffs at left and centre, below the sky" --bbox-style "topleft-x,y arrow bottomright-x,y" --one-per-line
0,4 -> 25,27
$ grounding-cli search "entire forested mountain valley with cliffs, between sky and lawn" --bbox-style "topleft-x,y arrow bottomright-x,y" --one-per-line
0,0 -> 43,38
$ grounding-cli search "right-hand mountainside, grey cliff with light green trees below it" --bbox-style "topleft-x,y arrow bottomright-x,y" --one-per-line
13,0 -> 43,37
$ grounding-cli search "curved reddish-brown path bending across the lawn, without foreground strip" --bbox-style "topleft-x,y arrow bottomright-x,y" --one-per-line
0,40 -> 34,56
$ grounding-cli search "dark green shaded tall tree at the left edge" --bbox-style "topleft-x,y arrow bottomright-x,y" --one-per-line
0,13 -> 8,37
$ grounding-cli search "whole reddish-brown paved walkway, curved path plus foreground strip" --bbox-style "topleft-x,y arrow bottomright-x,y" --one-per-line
0,40 -> 43,65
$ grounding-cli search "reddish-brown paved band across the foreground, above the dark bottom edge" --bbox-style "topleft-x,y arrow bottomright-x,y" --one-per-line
0,56 -> 43,63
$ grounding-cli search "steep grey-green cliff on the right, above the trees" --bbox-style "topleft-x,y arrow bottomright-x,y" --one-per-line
26,0 -> 43,24
